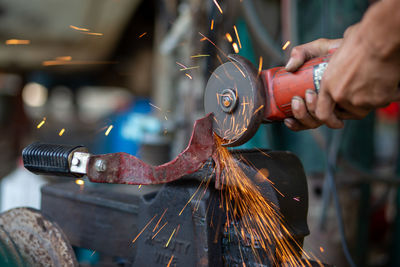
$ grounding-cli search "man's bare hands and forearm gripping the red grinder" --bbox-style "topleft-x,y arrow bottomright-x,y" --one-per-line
285,0 -> 400,130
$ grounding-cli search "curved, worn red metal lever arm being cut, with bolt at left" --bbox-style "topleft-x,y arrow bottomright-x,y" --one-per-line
87,114 -> 215,185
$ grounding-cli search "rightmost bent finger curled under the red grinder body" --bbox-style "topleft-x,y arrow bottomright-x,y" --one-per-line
315,90 -> 344,129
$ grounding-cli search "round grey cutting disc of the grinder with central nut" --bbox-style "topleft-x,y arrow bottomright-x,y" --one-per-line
204,55 -> 265,146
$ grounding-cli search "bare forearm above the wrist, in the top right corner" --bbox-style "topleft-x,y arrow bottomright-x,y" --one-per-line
358,0 -> 400,60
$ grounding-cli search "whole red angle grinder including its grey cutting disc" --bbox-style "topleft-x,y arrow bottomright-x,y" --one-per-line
204,51 -> 332,146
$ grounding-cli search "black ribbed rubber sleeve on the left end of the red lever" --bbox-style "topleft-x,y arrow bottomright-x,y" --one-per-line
22,142 -> 87,177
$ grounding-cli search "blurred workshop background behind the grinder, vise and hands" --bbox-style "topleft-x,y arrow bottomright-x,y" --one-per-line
0,0 -> 400,266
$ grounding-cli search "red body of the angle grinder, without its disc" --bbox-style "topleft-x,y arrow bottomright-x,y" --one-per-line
261,49 -> 336,122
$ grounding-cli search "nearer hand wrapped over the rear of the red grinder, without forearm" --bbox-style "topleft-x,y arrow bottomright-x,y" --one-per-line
315,22 -> 400,128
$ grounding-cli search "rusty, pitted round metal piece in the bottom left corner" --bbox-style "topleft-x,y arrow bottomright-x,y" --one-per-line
0,208 -> 78,267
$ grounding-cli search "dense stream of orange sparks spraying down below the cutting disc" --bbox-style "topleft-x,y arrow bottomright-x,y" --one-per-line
212,138 -> 322,266
